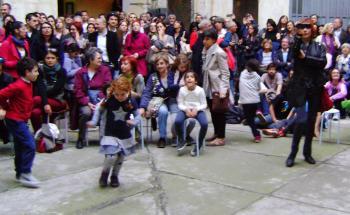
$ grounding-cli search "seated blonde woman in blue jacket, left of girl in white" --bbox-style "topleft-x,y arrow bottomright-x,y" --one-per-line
139,55 -> 179,148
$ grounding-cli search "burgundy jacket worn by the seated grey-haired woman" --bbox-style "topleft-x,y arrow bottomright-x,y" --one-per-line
74,66 -> 112,106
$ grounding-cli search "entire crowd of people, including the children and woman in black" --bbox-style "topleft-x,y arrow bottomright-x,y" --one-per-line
0,3 -> 350,187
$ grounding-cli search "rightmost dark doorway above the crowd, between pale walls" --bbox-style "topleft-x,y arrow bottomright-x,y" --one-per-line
233,0 -> 259,21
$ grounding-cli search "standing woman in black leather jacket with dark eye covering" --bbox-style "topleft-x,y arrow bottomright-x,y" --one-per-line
286,18 -> 327,167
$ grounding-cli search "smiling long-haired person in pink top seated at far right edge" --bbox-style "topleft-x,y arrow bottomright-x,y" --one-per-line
325,69 -> 348,119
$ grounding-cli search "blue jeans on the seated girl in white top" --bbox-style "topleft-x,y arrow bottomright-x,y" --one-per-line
175,111 -> 208,147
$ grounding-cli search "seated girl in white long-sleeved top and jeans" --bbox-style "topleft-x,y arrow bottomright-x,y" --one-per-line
175,71 -> 208,156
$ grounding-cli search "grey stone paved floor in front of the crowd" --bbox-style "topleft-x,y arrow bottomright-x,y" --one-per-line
0,120 -> 350,215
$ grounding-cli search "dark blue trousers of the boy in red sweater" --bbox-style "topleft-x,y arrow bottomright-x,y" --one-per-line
6,119 -> 35,176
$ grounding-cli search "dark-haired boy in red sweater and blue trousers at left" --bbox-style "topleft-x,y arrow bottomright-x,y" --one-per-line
0,57 -> 40,188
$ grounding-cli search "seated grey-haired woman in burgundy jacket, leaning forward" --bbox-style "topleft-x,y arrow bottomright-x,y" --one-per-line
74,47 -> 112,149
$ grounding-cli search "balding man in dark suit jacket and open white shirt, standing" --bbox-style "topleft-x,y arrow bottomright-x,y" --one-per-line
89,18 -> 121,77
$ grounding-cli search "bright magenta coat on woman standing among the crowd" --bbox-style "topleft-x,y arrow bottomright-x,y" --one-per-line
123,33 -> 151,77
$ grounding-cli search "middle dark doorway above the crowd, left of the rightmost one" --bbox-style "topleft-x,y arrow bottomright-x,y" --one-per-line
168,0 -> 192,27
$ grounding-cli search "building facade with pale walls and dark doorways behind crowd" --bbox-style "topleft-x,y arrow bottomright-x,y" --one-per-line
3,0 -> 350,27
